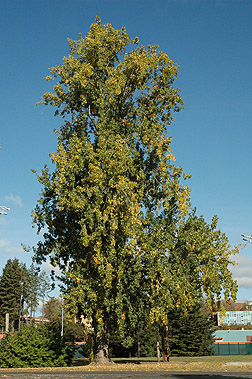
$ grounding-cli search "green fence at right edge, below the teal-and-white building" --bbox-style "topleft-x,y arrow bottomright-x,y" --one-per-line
214,342 -> 252,355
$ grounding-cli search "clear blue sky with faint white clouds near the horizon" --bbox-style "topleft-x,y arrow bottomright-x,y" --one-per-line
0,0 -> 252,300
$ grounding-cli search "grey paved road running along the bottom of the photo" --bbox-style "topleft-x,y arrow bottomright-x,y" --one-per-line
0,369 -> 252,379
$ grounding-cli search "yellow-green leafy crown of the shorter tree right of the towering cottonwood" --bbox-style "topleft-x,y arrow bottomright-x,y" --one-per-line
165,210 -> 239,310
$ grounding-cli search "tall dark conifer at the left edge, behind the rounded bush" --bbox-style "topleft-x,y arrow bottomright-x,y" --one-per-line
0,258 -> 27,328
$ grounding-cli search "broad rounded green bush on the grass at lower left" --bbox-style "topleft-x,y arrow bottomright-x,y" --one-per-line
0,323 -> 73,367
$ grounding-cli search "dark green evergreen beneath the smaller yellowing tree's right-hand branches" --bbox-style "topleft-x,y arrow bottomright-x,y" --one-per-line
168,307 -> 213,356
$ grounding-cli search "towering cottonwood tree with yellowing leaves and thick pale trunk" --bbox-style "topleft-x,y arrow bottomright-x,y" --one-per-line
33,17 -> 238,359
